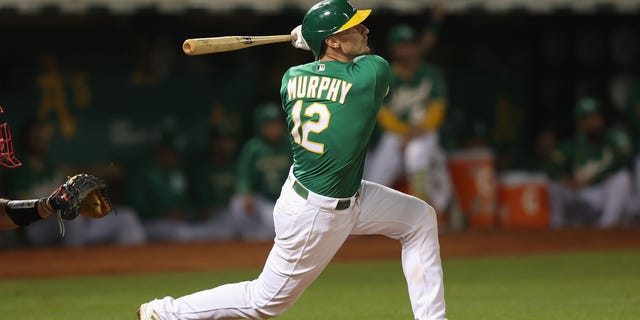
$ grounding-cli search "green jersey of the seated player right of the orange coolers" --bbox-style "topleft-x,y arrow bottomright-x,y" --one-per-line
547,130 -> 633,184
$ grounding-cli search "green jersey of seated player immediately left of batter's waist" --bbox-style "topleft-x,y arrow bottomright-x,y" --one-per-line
236,137 -> 291,201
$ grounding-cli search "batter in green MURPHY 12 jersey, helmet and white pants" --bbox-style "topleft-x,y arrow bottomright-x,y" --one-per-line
138,0 -> 446,320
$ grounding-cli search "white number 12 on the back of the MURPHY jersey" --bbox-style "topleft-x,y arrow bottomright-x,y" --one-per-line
291,100 -> 331,154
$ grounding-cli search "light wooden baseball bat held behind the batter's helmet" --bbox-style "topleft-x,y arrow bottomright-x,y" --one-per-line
182,34 -> 295,56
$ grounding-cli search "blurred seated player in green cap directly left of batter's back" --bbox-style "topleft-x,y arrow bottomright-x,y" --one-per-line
231,102 -> 292,240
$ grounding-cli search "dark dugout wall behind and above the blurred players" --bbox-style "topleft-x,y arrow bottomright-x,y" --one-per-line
0,10 -> 640,168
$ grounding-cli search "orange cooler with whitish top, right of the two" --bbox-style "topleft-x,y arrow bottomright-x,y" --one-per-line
498,172 -> 550,229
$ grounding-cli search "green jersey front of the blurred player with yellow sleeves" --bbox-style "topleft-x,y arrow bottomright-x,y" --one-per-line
385,62 -> 447,126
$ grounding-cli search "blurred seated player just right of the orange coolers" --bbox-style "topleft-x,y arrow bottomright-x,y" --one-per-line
546,98 -> 632,228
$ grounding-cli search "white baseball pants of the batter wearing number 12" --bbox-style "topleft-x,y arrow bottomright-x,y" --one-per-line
148,171 -> 446,320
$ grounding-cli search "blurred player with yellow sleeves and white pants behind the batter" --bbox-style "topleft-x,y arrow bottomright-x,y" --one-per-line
365,25 -> 452,212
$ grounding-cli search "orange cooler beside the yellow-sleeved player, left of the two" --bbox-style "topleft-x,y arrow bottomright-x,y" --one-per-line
449,148 -> 497,229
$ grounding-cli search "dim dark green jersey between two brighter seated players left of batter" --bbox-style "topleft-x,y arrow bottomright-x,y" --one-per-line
192,161 -> 236,209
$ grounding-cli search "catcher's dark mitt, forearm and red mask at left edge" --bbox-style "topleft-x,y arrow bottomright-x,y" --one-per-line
0,107 -> 111,231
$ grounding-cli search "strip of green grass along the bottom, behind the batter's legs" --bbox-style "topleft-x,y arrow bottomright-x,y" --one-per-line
0,251 -> 640,320
